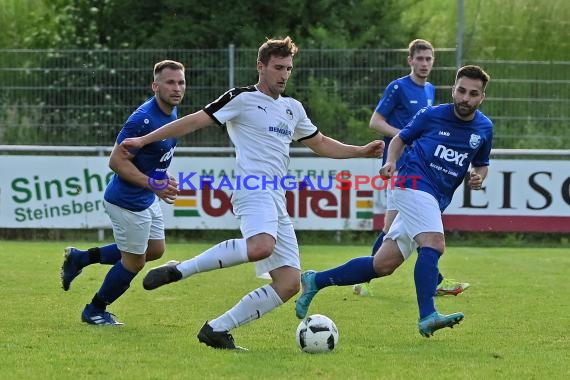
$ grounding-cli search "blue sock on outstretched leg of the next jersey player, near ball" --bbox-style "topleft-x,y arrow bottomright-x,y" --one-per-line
315,256 -> 378,289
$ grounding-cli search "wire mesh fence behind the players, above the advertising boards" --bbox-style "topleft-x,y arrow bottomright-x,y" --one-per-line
0,46 -> 570,149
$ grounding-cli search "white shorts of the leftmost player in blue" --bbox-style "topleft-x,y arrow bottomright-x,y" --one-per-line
103,197 -> 164,255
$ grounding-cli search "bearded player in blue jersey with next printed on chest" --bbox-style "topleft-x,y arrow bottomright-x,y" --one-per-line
295,66 -> 493,337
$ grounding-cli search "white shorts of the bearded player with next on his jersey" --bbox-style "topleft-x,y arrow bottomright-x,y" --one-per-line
384,189 -> 443,260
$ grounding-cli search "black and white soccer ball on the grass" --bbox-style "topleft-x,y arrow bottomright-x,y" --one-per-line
296,314 -> 338,354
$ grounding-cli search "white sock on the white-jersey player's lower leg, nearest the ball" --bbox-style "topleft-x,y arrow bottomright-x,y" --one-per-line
208,285 -> 283,331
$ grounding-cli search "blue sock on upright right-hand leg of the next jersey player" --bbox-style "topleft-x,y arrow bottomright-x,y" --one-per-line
414,247 -> 441,319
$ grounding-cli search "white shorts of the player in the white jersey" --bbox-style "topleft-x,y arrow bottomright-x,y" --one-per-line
232,190 -> 301,276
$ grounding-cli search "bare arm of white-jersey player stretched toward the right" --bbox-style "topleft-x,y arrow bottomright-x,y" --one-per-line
302,132 -> 384,158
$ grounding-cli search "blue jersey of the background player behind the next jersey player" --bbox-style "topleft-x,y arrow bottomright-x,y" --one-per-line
375,75 -> 435,163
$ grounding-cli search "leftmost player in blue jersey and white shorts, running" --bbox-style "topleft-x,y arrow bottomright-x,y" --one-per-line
61,60 -> 186,325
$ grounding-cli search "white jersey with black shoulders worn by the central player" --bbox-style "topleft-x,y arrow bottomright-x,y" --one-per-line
204,86 -> 318,180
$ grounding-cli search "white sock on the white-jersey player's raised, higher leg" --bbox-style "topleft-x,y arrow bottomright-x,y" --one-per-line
176,239 -> 249,278
